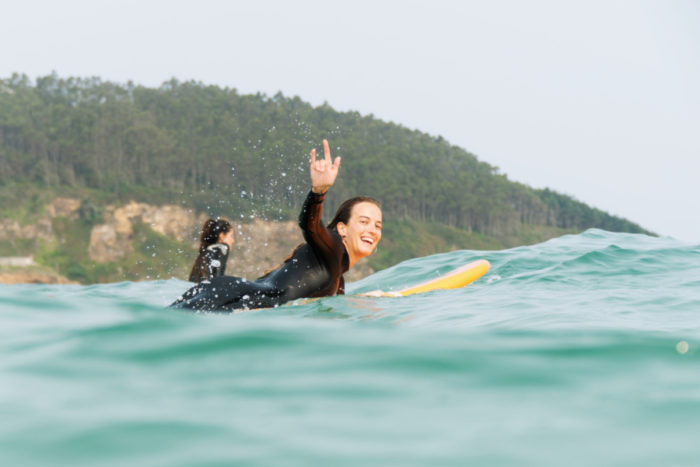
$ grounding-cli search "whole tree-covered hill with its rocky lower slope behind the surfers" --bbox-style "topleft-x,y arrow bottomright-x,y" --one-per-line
0,74 -> 654,284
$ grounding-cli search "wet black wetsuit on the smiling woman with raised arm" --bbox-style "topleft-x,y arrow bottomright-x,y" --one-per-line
170,192 -> 349,311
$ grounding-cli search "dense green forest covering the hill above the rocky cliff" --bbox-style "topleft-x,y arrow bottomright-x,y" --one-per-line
0,74 -> 644,245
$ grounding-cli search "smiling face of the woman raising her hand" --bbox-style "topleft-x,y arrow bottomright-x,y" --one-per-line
337,201 -> 382,261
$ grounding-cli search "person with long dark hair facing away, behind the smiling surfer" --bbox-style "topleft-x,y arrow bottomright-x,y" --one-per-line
189,217 -> 236,282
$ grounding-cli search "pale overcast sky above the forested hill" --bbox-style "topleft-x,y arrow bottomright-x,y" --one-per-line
0,0 -> 700,243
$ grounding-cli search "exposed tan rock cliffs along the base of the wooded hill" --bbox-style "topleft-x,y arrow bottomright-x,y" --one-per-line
0,197 -> 373,283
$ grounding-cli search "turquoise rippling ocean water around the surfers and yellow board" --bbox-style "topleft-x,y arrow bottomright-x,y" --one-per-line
0,230 -> 700,466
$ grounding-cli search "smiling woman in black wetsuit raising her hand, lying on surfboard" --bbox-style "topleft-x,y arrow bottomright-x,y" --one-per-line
171,140 -> 382,311
